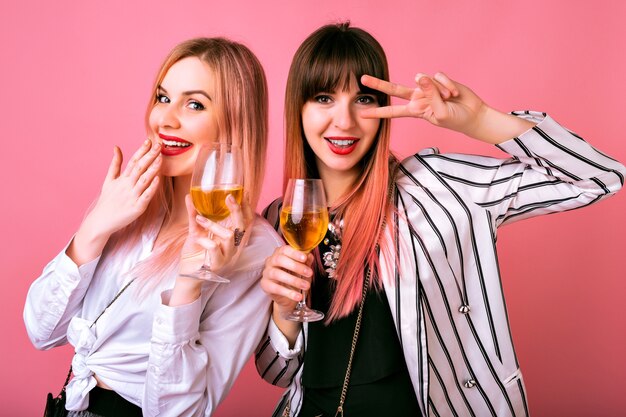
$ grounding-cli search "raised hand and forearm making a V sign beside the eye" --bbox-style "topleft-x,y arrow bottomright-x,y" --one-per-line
361,72 -> 533,144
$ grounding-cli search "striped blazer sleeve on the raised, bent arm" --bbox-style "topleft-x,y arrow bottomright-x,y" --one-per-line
422,111 -> 625,225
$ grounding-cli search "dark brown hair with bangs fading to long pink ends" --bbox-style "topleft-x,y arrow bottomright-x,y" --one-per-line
283,22 -> 397,321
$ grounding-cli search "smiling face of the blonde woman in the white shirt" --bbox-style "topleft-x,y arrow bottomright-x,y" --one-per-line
148,57 -> 219,177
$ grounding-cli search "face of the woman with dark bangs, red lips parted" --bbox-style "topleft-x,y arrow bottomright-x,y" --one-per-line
302,76 -> 380,183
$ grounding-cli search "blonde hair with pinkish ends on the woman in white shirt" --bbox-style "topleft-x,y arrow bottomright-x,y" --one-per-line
105,38 -> 268,289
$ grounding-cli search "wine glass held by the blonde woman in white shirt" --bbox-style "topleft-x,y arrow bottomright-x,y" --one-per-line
182,143 -> 243,283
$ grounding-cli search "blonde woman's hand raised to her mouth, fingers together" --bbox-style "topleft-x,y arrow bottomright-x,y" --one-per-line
66,139 -> 161,265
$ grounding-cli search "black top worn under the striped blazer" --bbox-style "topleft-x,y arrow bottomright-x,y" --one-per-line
299,228 -> 421,417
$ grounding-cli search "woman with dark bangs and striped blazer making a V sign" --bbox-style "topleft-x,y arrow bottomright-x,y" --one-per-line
256,23 -> 625,417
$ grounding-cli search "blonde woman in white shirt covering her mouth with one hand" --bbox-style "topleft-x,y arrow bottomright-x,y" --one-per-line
24,38 -> 280,417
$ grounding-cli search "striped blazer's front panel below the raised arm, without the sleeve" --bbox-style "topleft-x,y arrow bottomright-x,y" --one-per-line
394,152 -> 518,416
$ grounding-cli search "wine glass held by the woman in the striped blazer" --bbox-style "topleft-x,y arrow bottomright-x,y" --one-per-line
280,179 -> 328,322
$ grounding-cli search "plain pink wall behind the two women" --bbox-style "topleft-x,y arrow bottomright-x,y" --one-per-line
0,0 -> 626,417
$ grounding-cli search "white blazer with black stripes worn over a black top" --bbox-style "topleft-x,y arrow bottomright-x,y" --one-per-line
256,112 -> 625,417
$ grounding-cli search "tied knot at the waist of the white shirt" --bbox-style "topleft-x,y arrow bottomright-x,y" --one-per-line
65,317 -> 96,411
